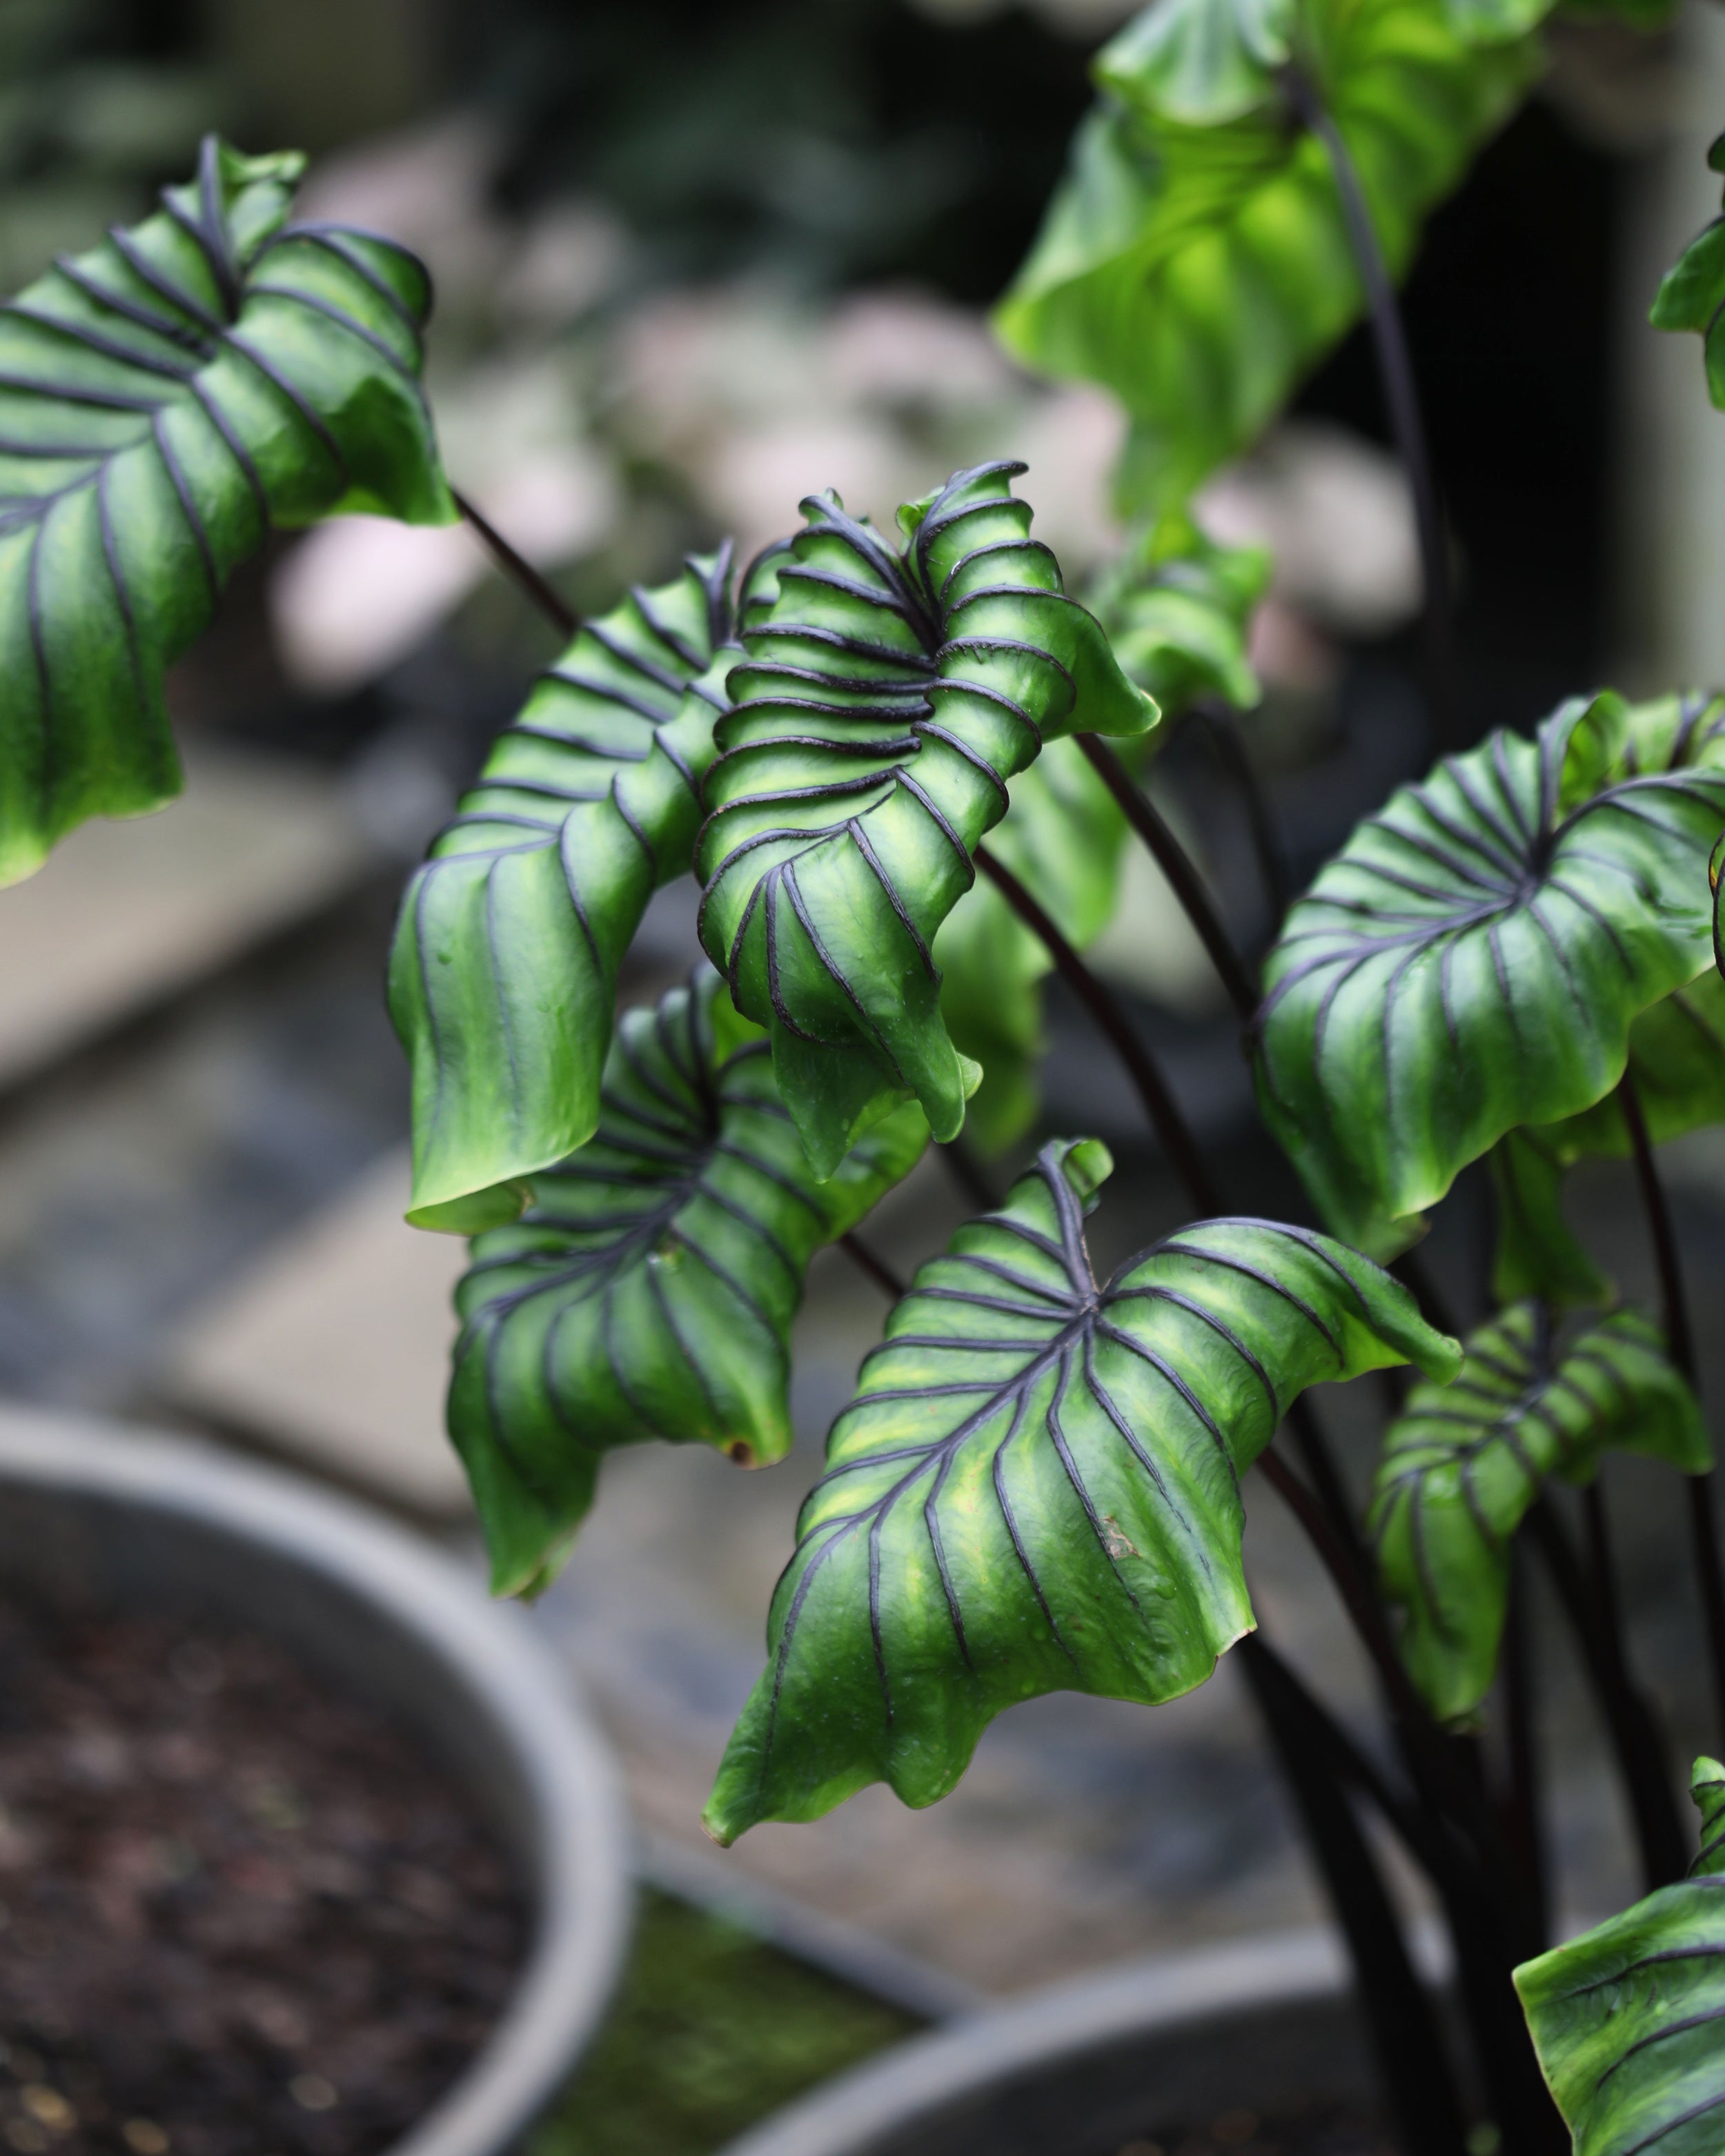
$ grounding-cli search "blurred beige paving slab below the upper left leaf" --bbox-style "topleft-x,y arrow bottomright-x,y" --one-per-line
0,751 -> 371,1089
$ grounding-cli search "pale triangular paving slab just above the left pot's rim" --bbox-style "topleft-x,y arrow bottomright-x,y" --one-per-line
157,1149 -> 468,1518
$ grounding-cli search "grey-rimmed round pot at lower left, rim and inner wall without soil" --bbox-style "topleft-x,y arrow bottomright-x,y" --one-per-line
0,1410 -> 630,2156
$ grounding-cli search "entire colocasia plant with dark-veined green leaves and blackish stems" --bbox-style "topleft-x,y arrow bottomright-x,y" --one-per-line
23,0 -> 1725,2156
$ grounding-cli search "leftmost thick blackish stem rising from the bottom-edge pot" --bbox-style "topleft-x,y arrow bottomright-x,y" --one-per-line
1236,1634 -> 1466,2156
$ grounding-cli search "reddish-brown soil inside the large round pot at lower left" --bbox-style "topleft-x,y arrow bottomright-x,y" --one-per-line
0,1604 -> 526,2156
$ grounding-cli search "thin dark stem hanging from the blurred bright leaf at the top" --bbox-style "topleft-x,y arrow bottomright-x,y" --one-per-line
1283,67 -> 1460,742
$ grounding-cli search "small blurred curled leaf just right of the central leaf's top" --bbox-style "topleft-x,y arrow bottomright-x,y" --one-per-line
1091,515 -> 1272,718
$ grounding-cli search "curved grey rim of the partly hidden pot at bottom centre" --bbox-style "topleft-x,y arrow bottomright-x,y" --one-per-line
720,1926 -> 1350,2156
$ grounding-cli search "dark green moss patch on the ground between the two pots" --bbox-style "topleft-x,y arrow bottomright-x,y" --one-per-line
526,1893 -> 920,2156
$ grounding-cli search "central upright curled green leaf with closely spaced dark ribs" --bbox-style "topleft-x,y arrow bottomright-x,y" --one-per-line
696,464 -> 1158,1175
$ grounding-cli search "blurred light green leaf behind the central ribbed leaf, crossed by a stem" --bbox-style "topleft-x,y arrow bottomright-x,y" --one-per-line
934,742 -> 1125,1158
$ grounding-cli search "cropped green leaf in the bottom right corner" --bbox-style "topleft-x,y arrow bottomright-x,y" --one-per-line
1516,1759 -> 1725,2156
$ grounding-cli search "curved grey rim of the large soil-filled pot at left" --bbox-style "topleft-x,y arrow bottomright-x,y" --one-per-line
0,1406 -> 634,2156
